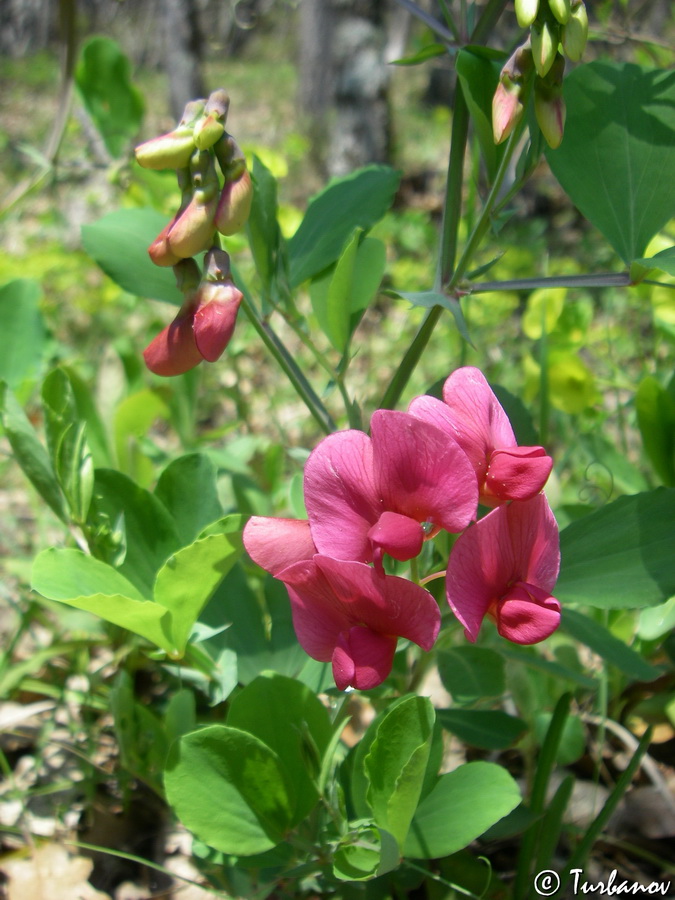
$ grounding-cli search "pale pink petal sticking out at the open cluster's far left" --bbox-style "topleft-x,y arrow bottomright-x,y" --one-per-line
243,516 -> 316,575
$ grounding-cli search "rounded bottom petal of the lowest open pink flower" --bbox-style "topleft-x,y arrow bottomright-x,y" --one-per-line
333,625 -> 396,691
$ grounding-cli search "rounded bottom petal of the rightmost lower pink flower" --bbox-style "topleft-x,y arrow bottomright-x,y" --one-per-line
496,582 -> 560,644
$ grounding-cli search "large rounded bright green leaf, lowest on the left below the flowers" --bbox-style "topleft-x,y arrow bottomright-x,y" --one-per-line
164,725 -> 295,856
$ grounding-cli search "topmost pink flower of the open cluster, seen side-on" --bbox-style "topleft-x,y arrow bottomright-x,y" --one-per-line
409,366 -> 553,506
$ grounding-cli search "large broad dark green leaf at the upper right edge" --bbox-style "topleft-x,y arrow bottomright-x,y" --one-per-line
546,61 -> 675,264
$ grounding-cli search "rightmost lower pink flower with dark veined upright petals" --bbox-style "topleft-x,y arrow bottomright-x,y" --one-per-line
446,494 -> 560,644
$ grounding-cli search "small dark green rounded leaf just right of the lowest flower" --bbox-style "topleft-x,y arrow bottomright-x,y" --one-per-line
438,646 -> 506,703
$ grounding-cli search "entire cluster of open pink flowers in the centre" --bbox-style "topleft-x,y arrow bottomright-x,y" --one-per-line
244,367 -> 560,690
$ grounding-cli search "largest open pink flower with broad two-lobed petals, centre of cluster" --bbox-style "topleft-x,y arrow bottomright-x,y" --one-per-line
304,410 -> 478,574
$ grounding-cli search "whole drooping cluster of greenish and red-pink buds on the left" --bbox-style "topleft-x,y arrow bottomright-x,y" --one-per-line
136,90 -> 253,375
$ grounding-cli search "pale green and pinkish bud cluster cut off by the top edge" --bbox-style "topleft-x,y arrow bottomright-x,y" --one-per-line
492,0 -> 588,148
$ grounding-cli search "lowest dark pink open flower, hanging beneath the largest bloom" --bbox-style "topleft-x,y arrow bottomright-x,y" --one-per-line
277,554 -> 441,690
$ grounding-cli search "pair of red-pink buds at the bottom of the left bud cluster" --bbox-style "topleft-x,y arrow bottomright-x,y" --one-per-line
143,247 -> 243,376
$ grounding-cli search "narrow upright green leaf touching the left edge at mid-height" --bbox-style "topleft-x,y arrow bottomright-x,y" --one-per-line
0,382 -> 68,522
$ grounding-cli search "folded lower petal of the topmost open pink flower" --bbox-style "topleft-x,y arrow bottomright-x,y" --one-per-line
483,447 -> 553,506
